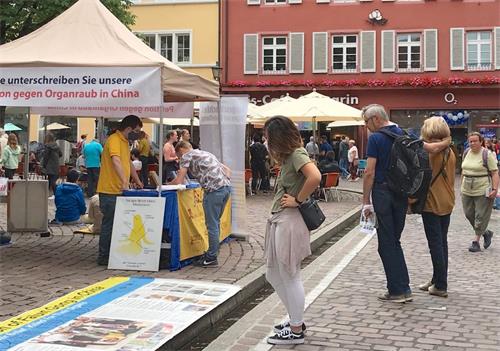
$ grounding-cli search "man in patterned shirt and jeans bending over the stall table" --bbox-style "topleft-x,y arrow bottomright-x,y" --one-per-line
169,141 -> 231,267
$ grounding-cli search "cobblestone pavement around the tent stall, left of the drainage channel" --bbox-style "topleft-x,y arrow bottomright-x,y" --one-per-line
0,186 -> 360,320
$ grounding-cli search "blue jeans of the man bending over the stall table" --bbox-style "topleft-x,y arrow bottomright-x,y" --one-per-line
203,186 -> 231,259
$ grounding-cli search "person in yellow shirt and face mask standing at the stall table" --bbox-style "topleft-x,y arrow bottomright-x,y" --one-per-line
97,115 -> 143,266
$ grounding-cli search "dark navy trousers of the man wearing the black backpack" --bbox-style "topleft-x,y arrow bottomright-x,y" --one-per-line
372,183 -> 411,295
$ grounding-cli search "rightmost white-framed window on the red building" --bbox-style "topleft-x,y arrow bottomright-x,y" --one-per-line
466,31 -> 492,71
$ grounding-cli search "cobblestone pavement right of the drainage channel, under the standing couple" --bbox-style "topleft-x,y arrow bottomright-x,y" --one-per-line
208,190 -> 500,351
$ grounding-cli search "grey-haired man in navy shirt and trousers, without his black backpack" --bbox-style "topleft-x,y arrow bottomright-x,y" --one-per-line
362,104 -> 449,303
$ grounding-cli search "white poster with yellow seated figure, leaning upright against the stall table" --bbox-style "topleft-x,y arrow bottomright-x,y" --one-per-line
108,197 -> 165,272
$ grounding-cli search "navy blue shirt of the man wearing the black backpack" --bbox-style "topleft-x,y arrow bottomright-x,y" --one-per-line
366,125 -> 403,183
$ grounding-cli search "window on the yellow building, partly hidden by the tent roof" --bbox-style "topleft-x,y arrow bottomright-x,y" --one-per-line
138,32 -> 191,63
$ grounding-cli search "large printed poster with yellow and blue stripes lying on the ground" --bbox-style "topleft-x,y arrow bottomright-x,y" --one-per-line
0,277 -> 241,351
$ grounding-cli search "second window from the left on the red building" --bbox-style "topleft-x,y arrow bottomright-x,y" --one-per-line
332,35 -> 358,73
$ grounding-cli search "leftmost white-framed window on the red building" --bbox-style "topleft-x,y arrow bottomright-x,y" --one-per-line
262,37 -> 287,74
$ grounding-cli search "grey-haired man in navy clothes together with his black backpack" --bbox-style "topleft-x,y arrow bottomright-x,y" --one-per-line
362,104 -> 449,303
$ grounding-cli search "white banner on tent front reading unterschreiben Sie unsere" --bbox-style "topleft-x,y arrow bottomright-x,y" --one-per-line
0,67 -> 161,106
